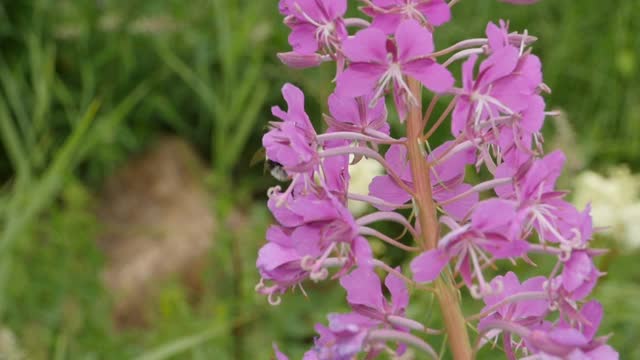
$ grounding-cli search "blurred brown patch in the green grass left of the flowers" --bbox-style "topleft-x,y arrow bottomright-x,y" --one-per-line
98,138 -> 214,327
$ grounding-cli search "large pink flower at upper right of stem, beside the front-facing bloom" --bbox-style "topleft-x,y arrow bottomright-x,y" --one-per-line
452,22 -> 545,162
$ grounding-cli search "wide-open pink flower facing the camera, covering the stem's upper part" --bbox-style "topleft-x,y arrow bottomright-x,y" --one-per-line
336,20 -> 454,119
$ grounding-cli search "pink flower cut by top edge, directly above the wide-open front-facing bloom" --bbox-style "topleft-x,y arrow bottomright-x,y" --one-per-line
362,0 -> 451,34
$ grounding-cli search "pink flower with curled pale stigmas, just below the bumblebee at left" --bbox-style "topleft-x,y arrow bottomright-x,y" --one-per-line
256,186 -> 372,303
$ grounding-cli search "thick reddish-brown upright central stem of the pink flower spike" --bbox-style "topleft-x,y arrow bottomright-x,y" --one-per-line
407,79 -> 472,360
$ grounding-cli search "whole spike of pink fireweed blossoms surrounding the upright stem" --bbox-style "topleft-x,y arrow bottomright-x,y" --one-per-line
256,0 -> 618,360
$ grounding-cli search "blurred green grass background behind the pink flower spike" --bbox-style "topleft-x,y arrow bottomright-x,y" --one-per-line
0,0 -> 640,360
